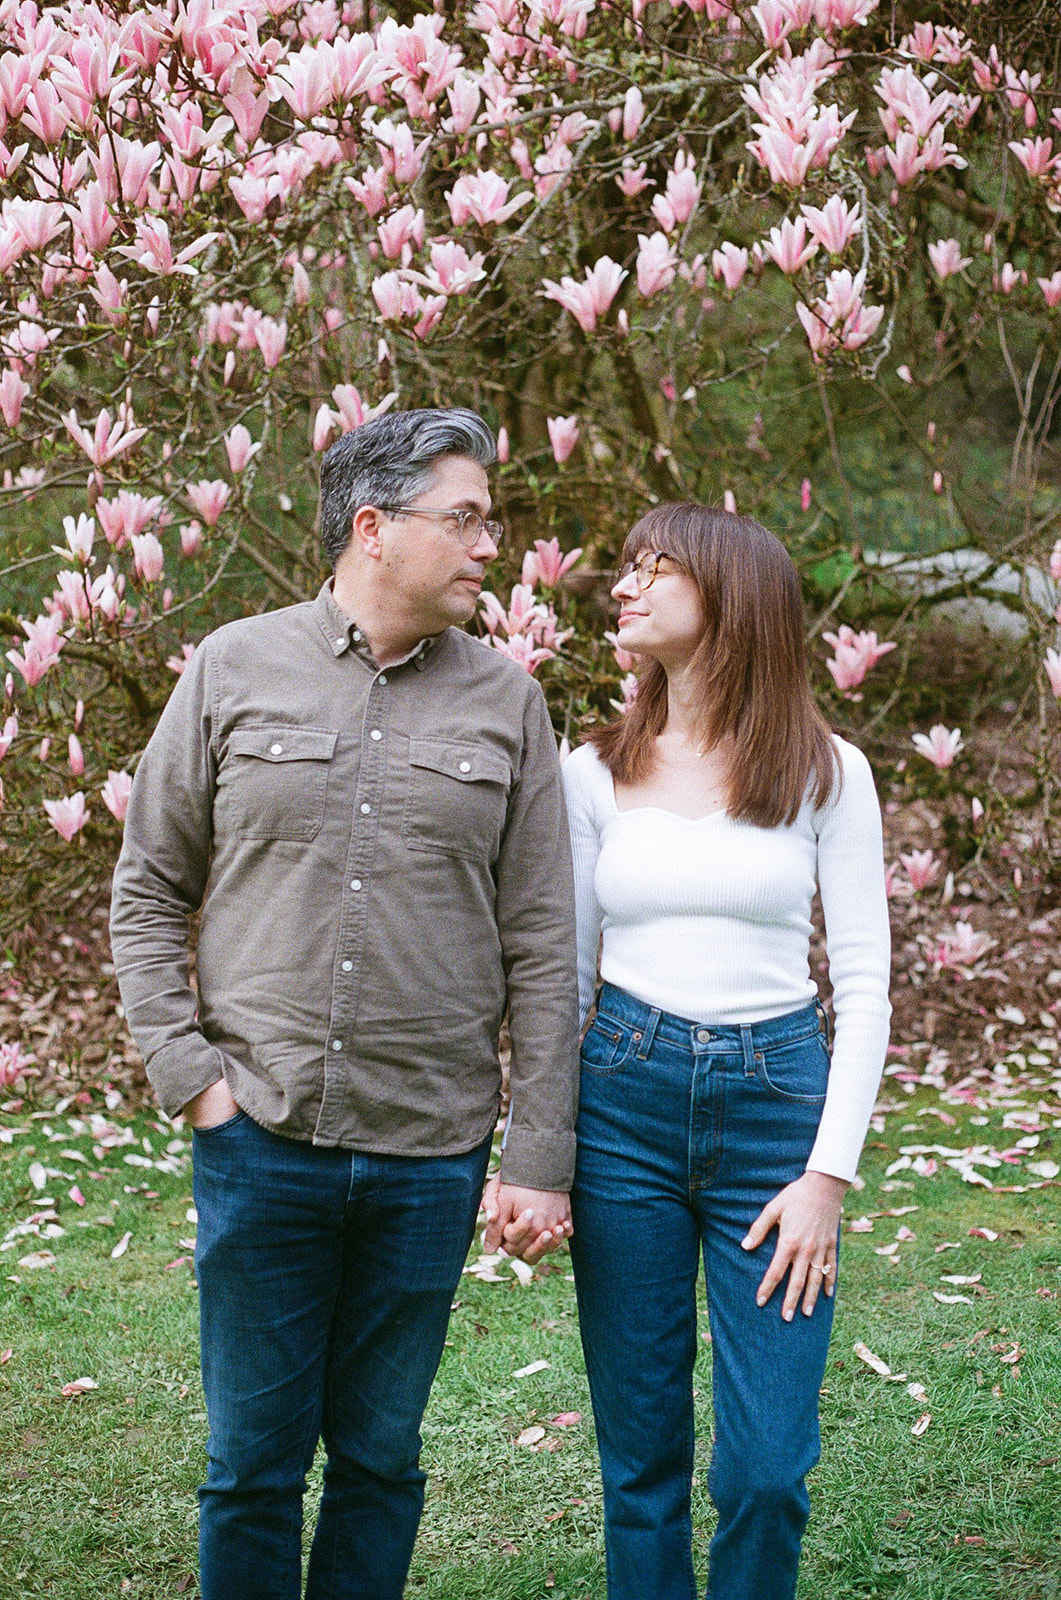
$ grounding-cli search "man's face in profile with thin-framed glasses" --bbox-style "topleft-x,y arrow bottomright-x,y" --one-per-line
379,456 -> 498,635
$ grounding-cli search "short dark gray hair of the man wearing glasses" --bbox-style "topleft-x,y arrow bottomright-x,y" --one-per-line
320,406 -> 498,570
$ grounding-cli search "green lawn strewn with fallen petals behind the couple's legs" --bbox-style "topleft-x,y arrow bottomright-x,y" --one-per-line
0,1078 -> 1061,1600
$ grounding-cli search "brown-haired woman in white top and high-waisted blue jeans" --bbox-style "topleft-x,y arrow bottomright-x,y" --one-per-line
565,506 -> 890,1600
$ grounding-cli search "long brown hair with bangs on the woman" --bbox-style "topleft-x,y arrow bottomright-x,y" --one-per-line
587,504 -> 842,827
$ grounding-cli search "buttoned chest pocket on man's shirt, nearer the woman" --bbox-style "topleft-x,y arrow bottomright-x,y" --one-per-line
402,739 -> 512,862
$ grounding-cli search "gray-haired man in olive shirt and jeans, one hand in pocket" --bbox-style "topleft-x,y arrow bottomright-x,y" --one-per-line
110,410 -> 578,1600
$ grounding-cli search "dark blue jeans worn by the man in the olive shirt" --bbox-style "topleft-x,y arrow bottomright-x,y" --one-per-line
194,1112 -> 490,1600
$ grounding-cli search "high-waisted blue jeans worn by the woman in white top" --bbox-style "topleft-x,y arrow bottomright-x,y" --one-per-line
571,984 -> 832,1600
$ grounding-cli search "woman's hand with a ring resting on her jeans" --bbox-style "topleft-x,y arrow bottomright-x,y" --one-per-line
741,1171 -> 848,1322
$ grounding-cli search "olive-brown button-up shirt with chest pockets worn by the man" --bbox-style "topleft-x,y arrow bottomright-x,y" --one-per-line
110,584 -> 578,1189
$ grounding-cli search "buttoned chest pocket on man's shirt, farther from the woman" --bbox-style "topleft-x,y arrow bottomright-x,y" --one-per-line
218,726 -> 339,843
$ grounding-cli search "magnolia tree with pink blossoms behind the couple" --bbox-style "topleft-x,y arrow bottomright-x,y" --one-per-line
0,0 -> 1061,925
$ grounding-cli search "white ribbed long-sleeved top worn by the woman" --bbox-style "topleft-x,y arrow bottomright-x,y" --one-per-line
563,739 -> 891,1179
